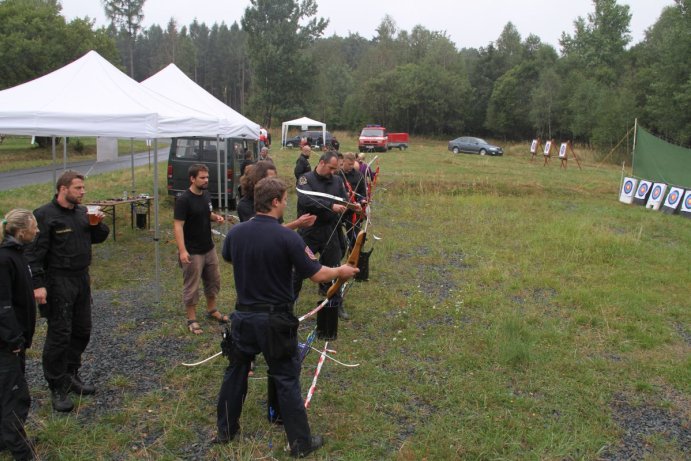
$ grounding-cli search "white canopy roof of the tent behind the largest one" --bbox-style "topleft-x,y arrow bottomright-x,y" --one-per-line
141,63 -> 259,139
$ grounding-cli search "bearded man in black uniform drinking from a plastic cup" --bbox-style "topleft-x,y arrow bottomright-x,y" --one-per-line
26,171 -> 110,412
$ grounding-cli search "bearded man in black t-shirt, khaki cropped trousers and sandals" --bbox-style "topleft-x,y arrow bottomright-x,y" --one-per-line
173,164 -> 228,335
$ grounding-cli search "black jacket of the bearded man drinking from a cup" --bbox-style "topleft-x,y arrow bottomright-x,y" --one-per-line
26,198 -> 110,288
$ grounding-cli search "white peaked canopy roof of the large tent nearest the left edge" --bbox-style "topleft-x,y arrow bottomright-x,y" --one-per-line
0,51 -> 221,138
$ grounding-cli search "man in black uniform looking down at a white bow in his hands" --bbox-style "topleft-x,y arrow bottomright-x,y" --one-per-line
294,151 -> 359,319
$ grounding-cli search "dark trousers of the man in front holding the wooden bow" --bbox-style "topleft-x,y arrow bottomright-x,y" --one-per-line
216,312 -> 311,448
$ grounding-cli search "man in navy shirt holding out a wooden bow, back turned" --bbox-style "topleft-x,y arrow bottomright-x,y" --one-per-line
215,177 -> 358,458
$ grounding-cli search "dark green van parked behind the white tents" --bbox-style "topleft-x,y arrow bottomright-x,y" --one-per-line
168,137 -> 259,210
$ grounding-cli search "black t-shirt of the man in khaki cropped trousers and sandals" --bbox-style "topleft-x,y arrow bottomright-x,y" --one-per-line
173,189 -> 214,255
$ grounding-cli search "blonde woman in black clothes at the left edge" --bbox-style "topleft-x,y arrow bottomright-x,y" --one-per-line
0,209 -> 38,460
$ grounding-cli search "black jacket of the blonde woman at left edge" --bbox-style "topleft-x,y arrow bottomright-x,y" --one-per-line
0,236 -> 36,352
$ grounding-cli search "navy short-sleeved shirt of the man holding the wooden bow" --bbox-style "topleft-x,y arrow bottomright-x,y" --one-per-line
222,215 -> 321,305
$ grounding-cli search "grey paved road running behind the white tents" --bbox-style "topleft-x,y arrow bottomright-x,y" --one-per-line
0,147 -> 168,191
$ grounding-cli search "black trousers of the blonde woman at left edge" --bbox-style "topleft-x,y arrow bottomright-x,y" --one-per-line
0,351 -> 33,459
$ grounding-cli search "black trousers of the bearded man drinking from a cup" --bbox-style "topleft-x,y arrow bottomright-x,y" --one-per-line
43,274 -> 91,389
